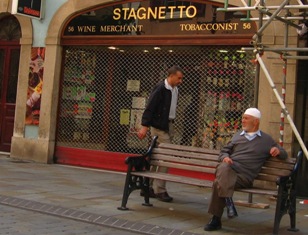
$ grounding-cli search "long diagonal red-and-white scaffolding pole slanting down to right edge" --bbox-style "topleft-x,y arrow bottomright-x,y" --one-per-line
256,53 -> 308,160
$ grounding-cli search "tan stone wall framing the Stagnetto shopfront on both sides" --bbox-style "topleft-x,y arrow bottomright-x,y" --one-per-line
0,0 -> 297,163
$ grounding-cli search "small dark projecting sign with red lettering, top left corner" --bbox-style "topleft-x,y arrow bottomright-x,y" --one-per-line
12,0 -> 45,19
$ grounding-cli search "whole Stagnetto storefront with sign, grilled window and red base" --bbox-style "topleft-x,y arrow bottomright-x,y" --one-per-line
55,0 -> 257,170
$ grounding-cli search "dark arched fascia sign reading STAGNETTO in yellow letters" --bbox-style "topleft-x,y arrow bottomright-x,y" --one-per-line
64,1 -> 255,36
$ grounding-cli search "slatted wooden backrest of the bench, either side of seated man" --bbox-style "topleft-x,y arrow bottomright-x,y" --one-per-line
151,143 -> 296,186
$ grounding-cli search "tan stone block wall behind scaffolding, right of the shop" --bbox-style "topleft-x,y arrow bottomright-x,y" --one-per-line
253,1 -> 298,154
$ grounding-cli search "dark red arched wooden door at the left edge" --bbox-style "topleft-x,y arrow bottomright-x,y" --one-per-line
0,15 -> 21,152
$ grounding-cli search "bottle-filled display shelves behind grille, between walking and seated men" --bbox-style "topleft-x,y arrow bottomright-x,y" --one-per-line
201,58 -> 246,149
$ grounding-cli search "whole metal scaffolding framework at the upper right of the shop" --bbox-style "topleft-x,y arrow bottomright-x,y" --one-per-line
217,0 -> 308,159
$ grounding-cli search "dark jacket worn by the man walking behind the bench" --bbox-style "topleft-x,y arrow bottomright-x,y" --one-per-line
141,80 -> 172,131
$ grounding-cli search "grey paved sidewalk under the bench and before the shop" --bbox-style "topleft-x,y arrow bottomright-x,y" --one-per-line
0,156 -> 308,235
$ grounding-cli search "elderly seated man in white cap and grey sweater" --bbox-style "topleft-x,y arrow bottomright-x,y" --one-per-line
204,108 -> 287,231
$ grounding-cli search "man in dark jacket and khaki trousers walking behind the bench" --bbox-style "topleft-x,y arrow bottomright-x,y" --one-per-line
138,65 -> 183,202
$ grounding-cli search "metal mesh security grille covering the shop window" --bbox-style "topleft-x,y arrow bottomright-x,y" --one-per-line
57,46 -> 255,153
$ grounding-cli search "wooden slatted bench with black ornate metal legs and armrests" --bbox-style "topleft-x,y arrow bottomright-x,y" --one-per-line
118,137 -> 302,234
